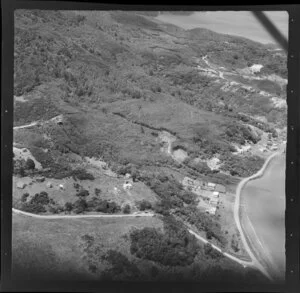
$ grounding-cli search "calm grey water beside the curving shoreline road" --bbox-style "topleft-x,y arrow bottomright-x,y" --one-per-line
242,155 -> 285,278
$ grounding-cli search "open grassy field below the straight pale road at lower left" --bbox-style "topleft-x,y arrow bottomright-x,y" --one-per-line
12,214 -> 162,280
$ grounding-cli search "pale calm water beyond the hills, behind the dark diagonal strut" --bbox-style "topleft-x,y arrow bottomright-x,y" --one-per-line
157,11 -> 288,43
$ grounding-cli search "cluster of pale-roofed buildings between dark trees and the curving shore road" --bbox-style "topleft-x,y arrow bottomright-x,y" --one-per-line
182,177 -> 226,215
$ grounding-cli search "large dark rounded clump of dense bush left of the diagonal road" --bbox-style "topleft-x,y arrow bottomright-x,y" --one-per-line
130,217 -> 199,266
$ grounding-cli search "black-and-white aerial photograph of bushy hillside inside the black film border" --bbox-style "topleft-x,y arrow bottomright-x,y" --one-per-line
12,9 -> 288,284
